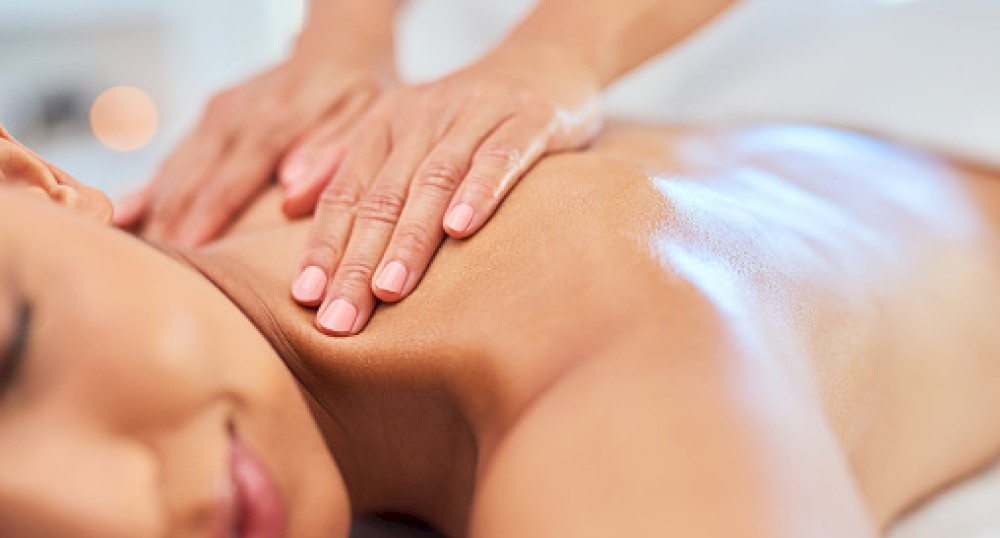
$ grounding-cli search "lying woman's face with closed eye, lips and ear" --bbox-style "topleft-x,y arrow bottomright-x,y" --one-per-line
0,131 -> 349,538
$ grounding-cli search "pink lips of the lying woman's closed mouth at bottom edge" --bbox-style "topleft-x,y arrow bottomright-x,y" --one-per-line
221,431 -> 286,538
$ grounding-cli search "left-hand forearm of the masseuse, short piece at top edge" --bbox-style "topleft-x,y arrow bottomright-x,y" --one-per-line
295,0 -> 404,68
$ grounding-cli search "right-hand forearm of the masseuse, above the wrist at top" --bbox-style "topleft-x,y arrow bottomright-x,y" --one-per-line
500,0 -> 736,86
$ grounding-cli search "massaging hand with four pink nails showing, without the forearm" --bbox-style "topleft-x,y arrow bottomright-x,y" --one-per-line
286,47 -> 601,335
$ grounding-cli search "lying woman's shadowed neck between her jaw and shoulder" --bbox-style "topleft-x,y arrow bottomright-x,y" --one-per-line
174,228 -> 478,535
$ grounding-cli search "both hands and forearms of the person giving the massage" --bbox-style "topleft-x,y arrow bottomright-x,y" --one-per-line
116,0 -> 735,336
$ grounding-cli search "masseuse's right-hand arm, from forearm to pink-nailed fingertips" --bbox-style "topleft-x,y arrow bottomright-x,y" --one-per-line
287,0 -> 744,336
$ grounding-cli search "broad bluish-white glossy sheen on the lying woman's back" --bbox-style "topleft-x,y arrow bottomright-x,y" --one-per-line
649,122 -> 989,376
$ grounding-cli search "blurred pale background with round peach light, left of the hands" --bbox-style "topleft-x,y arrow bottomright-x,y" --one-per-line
0,0 -> 303,196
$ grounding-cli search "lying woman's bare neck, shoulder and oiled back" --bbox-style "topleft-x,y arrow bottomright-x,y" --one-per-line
1,127 -> 1000,537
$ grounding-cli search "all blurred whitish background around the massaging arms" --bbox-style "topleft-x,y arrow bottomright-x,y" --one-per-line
0,0 -> 1000,201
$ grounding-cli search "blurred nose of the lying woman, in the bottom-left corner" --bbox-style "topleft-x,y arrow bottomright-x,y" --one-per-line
0,418 -> 163,538
